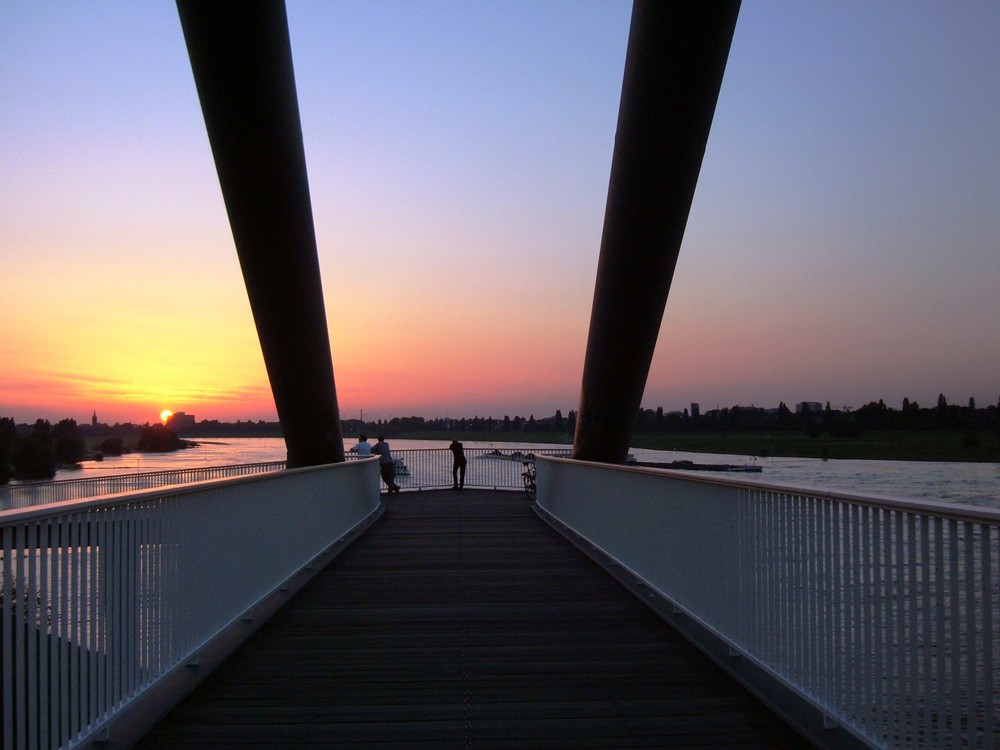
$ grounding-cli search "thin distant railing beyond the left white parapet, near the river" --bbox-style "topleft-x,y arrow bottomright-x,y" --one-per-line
0,461 -> 285,511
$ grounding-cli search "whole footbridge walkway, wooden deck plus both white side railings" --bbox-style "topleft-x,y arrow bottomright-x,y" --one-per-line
0,458 -> 1000,750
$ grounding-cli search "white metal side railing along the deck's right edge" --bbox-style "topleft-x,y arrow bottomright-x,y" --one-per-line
537,460 -> 1000,749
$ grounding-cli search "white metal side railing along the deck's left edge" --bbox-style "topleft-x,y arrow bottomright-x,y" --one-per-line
0,461 -> 379,750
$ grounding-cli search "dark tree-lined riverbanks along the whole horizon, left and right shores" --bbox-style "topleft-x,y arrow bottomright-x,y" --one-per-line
0,394 -> 1000,484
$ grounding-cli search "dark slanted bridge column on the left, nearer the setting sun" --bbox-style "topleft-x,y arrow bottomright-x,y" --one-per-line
177,0 -> 344,466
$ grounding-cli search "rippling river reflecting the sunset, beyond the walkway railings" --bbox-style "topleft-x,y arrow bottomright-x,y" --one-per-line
47,438 -> 1000,507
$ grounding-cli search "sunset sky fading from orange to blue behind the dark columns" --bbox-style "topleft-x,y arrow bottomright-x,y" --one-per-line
0,0 -> 1000,423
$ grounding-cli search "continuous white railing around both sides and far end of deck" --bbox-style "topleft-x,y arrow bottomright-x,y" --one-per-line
0,448 -> 1000,748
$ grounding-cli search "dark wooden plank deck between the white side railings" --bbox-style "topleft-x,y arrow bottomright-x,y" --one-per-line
133,491 -> 808,750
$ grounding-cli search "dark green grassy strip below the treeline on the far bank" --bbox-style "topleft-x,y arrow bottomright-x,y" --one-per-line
390,430 -> 1000,463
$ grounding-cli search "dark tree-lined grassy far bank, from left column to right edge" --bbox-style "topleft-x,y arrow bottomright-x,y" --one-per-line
356,395 -> 1000,463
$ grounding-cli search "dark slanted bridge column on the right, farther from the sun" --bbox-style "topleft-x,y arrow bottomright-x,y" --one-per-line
573,0 -> 740,463
